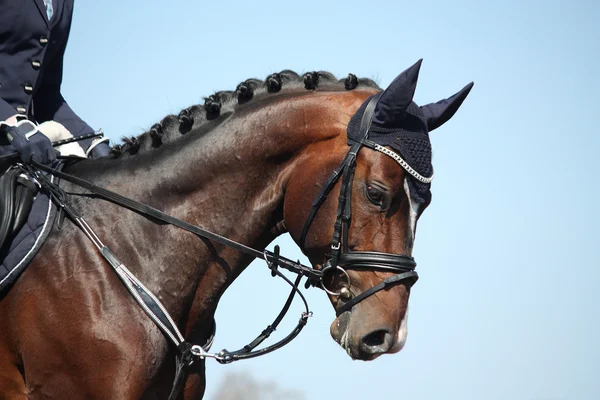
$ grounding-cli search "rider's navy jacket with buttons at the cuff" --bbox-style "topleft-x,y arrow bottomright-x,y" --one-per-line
0,0 -> 104,155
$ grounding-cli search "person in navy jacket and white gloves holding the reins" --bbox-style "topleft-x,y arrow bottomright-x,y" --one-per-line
0,0 -> 109,167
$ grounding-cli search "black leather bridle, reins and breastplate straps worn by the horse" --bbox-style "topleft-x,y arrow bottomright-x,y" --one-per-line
21,96 -> 418,399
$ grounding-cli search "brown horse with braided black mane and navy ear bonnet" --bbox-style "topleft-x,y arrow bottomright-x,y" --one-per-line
0,62 -> 472,399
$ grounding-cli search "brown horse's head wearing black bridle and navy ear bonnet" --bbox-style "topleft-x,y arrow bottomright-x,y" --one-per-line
285,61 -> 472,360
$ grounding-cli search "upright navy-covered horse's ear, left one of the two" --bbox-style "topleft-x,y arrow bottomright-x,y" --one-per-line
373,59 -> 423,127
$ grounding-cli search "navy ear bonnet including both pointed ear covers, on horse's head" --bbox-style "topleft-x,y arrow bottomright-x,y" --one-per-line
347,60 -> 473,203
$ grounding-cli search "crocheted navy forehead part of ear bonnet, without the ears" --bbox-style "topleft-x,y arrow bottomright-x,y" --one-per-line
348,94 -> 433,203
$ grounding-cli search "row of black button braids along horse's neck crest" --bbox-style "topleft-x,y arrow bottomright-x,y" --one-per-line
109,70 -> 381,158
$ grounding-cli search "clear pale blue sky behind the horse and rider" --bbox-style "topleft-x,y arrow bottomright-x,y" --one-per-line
63,0 -> 600,400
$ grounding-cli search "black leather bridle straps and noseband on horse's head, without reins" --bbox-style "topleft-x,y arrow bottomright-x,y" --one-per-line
300,96 -> 419,316
